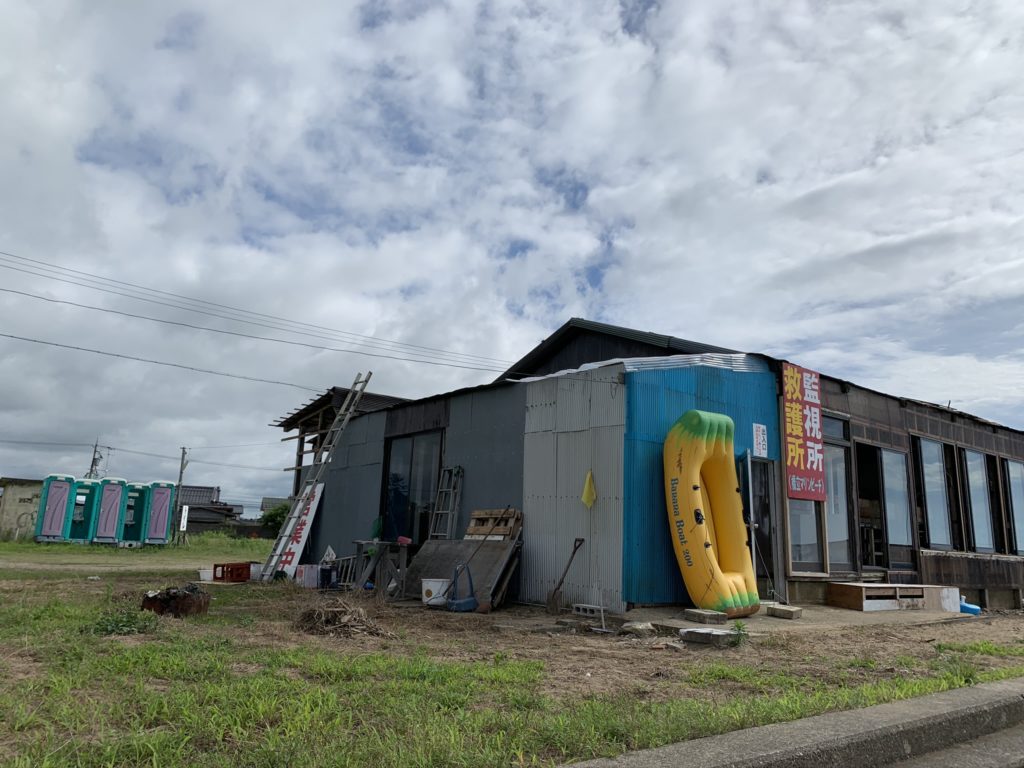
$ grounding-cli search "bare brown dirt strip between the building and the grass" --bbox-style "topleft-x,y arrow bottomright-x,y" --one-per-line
266,598 -> 1024,700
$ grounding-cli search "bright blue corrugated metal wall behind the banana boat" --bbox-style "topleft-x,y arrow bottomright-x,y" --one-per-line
623,364 -> 779,605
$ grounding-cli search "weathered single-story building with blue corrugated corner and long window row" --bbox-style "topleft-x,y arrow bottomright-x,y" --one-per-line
278,318 -> 1024,611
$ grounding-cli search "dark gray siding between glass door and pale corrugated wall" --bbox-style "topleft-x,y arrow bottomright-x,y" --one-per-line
443,384 -> 526,538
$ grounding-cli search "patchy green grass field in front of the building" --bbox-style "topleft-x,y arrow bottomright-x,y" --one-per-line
0,540 -> 1024,768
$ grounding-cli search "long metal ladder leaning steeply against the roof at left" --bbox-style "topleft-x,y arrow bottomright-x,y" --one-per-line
260,371 -> 373,582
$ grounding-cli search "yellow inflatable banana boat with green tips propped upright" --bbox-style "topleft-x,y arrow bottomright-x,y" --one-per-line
664,411 -> 760,617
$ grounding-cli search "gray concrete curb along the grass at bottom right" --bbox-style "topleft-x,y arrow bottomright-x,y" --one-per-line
573,679 -> 1024,768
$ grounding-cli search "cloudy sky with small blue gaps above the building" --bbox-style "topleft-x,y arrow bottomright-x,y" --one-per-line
0,0 -> 1024,515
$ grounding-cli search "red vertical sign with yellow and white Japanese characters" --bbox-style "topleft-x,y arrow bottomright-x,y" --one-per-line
782,362 -> 825,502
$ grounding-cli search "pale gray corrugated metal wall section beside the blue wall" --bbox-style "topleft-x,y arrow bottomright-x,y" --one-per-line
520,365 -> 626,612
